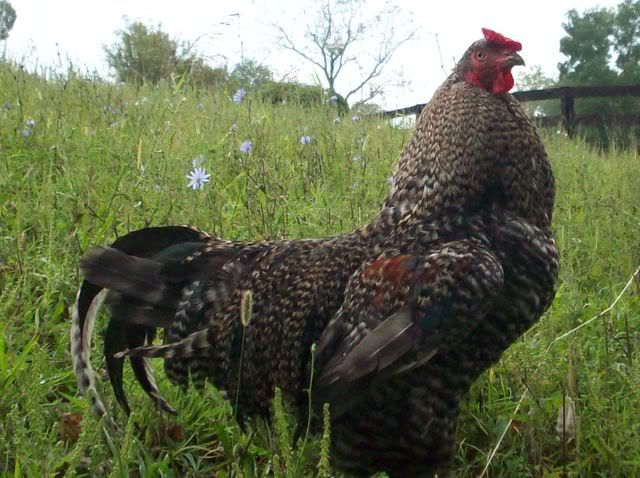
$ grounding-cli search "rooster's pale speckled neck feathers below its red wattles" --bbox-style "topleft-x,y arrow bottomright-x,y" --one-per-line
363,81 -> 554,243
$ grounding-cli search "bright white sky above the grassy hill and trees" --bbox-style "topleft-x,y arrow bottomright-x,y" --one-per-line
2,0 -> 622,109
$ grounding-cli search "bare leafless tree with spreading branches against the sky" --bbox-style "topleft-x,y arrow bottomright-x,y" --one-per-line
274,0 -> 416,102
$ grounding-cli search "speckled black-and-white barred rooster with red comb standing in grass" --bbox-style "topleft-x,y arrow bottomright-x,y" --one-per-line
71,29 -> 559,476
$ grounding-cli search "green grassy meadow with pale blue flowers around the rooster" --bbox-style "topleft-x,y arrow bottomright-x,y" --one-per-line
0,65 -> 640,477
